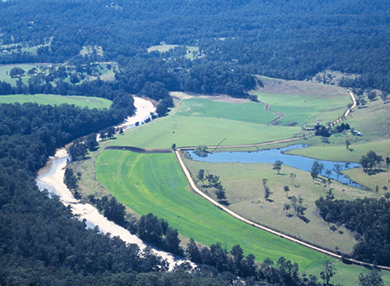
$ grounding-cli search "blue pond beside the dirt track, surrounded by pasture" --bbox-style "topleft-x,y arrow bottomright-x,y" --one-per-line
188,144 -> 361,187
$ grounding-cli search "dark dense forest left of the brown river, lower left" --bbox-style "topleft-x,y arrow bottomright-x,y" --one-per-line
0,104 -> 171,285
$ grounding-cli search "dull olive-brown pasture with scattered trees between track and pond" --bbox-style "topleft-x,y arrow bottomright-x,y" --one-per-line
185,159 -> 377,253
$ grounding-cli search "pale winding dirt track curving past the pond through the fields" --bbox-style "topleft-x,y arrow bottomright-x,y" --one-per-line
174,89 -> 390,270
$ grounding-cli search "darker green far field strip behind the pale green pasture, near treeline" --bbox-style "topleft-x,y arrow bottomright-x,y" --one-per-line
177,97 -> 276,124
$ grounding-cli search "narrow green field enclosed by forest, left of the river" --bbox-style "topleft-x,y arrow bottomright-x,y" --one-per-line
0,94 -> 112,109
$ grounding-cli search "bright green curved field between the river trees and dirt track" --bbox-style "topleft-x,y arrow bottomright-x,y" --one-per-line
95,150 -> 327,270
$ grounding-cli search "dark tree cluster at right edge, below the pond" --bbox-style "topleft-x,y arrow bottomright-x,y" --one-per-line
316,197 -> 390,266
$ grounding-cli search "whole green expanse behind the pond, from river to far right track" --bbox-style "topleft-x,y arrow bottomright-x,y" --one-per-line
113,87 -> 349,148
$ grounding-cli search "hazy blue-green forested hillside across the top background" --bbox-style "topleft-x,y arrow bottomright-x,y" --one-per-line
0,0 -> 390,91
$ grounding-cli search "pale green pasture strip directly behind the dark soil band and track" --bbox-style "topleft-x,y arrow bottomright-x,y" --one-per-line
112,114 -> 301,148
